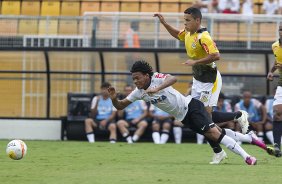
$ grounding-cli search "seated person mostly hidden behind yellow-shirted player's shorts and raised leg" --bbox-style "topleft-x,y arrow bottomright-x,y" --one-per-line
214,93 -> 235,130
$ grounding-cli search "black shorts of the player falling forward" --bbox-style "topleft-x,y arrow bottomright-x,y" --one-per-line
182,98 -> 215,134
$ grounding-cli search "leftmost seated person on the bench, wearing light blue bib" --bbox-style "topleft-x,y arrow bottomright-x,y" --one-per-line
84,82 -> 117,143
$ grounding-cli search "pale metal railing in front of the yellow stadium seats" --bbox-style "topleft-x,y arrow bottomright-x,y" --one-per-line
0,12 -> 282,49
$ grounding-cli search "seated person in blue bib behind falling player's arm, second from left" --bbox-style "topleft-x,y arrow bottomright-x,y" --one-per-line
117,85 -> 148,144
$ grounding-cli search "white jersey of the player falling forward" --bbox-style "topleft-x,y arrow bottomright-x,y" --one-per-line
126,72 -> 192,121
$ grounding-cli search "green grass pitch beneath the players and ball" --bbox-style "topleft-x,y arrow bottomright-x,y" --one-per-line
0,141 -> 282,184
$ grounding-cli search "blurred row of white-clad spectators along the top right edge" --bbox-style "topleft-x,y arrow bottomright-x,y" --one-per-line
193,0 -> 282,15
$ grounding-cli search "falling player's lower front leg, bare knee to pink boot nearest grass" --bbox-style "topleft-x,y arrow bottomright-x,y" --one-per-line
204,127 -> 257,165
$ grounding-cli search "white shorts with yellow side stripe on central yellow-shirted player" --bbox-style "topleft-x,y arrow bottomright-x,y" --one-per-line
191,71 -> 222,107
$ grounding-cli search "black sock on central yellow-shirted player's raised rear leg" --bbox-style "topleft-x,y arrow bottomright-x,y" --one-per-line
212,111 -> 242,123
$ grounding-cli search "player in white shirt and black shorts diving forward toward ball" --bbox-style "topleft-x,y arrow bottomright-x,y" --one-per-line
108,61 -> 257,165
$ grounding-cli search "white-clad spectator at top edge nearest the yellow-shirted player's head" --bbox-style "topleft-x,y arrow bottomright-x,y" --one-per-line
218,0 -> 240,14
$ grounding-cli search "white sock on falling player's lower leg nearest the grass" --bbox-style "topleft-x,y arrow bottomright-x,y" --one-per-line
220,135 -> 250,160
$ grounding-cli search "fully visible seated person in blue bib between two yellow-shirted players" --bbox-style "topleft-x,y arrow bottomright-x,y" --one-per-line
235,91 -> 266,140
